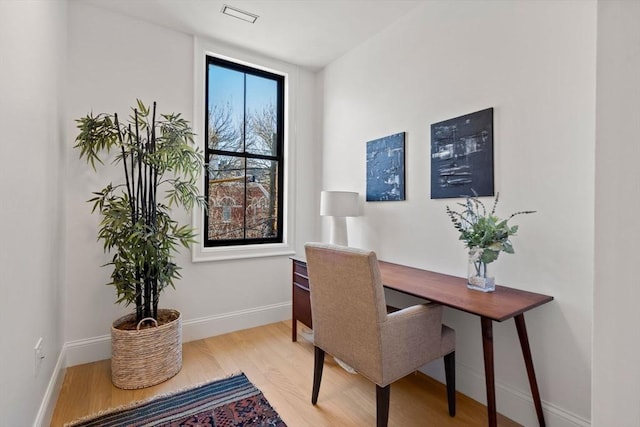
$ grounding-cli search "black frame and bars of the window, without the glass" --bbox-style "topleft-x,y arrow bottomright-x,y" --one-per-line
203,55 -> 286,248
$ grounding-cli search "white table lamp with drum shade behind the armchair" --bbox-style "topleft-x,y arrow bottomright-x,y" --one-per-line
320,191 -> 360,246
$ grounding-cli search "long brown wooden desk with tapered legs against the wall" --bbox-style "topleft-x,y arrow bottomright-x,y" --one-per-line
292,259 -> 553,427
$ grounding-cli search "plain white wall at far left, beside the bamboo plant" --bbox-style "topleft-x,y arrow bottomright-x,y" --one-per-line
0,1 -> 66,426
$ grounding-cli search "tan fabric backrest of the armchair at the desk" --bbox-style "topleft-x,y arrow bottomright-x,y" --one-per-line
305,243 -> 387,377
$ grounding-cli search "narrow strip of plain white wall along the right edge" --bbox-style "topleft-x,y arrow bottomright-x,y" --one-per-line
591,0 -> 640,427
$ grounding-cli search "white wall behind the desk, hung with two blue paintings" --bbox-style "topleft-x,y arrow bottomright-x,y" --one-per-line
320,1 -> 596,426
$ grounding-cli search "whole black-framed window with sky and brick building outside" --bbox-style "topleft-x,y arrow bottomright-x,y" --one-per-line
204,56 -> 285,247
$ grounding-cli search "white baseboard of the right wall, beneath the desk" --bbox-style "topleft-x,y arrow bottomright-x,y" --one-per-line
420,361 -> 591,427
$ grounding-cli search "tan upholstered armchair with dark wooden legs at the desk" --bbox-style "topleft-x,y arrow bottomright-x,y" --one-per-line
305,243 -> 455,427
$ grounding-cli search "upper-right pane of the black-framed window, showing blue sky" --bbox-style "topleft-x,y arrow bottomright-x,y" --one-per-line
246,75 -> 278,156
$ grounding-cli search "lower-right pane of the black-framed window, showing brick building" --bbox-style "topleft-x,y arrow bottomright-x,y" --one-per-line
246,159 -> 278,239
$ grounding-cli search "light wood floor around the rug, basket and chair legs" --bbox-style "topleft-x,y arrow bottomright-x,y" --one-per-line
51,321 -> 519,427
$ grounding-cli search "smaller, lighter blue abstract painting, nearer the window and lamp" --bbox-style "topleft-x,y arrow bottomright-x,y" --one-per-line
367,132 -> 405,202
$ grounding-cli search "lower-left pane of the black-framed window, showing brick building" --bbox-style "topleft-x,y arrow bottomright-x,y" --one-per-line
207,155 -> 246,240
